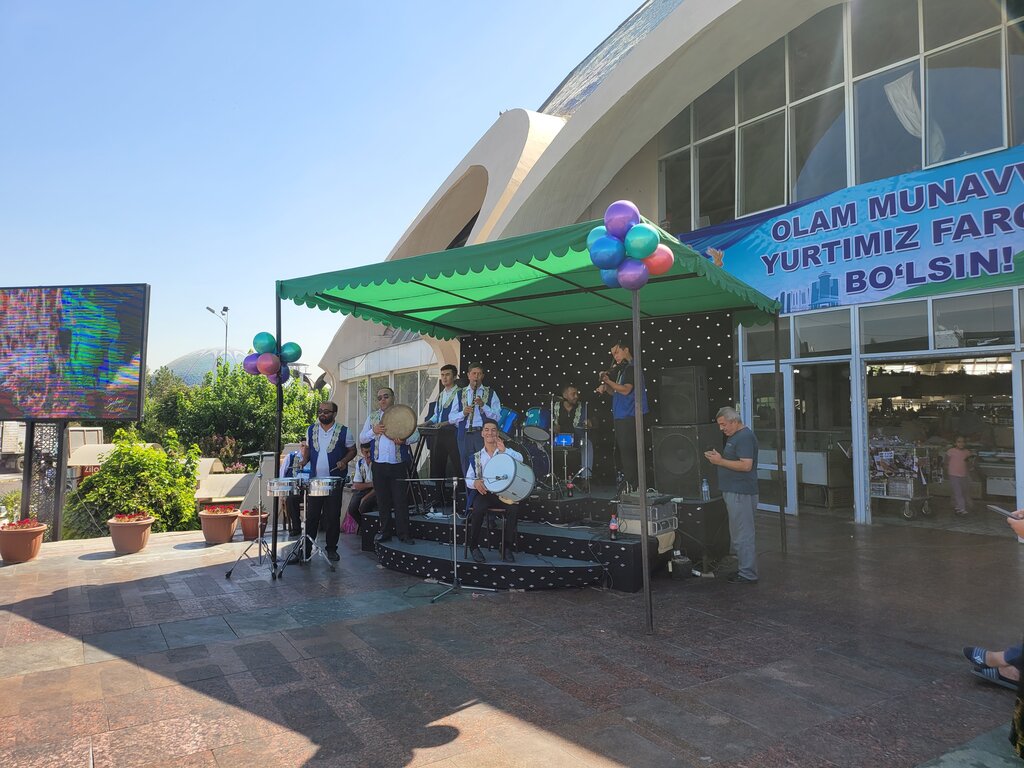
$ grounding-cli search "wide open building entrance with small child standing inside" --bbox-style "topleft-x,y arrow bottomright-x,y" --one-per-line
865,355 -> 1017,532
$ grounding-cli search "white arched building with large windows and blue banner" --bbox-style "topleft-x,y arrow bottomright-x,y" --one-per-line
321,0 -> 1024,522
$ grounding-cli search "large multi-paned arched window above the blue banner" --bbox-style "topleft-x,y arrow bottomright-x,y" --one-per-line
657,0 -> 1024,233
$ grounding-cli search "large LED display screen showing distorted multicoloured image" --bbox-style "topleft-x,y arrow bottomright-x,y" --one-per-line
0,285 -> 150,421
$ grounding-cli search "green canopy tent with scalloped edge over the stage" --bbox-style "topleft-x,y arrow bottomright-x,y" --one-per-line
278,215 -> 785,629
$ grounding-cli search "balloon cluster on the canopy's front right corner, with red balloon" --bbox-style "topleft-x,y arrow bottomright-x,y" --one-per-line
587,200 -> 676,291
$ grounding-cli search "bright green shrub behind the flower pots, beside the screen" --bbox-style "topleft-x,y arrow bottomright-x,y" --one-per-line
62,427 -> 200,539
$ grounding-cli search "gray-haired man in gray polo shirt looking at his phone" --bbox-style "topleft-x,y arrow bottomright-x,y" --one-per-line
705,407 -> 758,584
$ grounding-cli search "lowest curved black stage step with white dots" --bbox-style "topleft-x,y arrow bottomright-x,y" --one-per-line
375,539 -> 604,590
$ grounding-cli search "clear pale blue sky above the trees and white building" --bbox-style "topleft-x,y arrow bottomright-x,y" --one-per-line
0,0 -> 640,368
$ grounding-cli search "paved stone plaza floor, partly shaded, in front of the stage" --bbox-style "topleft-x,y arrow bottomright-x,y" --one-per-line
0,516 -> 1024,768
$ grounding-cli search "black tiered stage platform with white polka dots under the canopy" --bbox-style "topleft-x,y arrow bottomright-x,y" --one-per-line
360,497 -> 672,592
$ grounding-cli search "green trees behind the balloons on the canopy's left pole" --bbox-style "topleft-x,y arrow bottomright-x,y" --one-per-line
176,362 -> 328,464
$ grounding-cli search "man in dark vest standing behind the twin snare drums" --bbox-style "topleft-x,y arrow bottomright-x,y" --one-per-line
299,400 -> 355,562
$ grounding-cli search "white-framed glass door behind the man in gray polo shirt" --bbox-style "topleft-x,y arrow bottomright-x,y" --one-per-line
740,364 -> 797,514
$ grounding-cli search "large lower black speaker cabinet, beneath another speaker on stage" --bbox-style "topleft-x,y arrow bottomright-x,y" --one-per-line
653,424 -> 724,499
